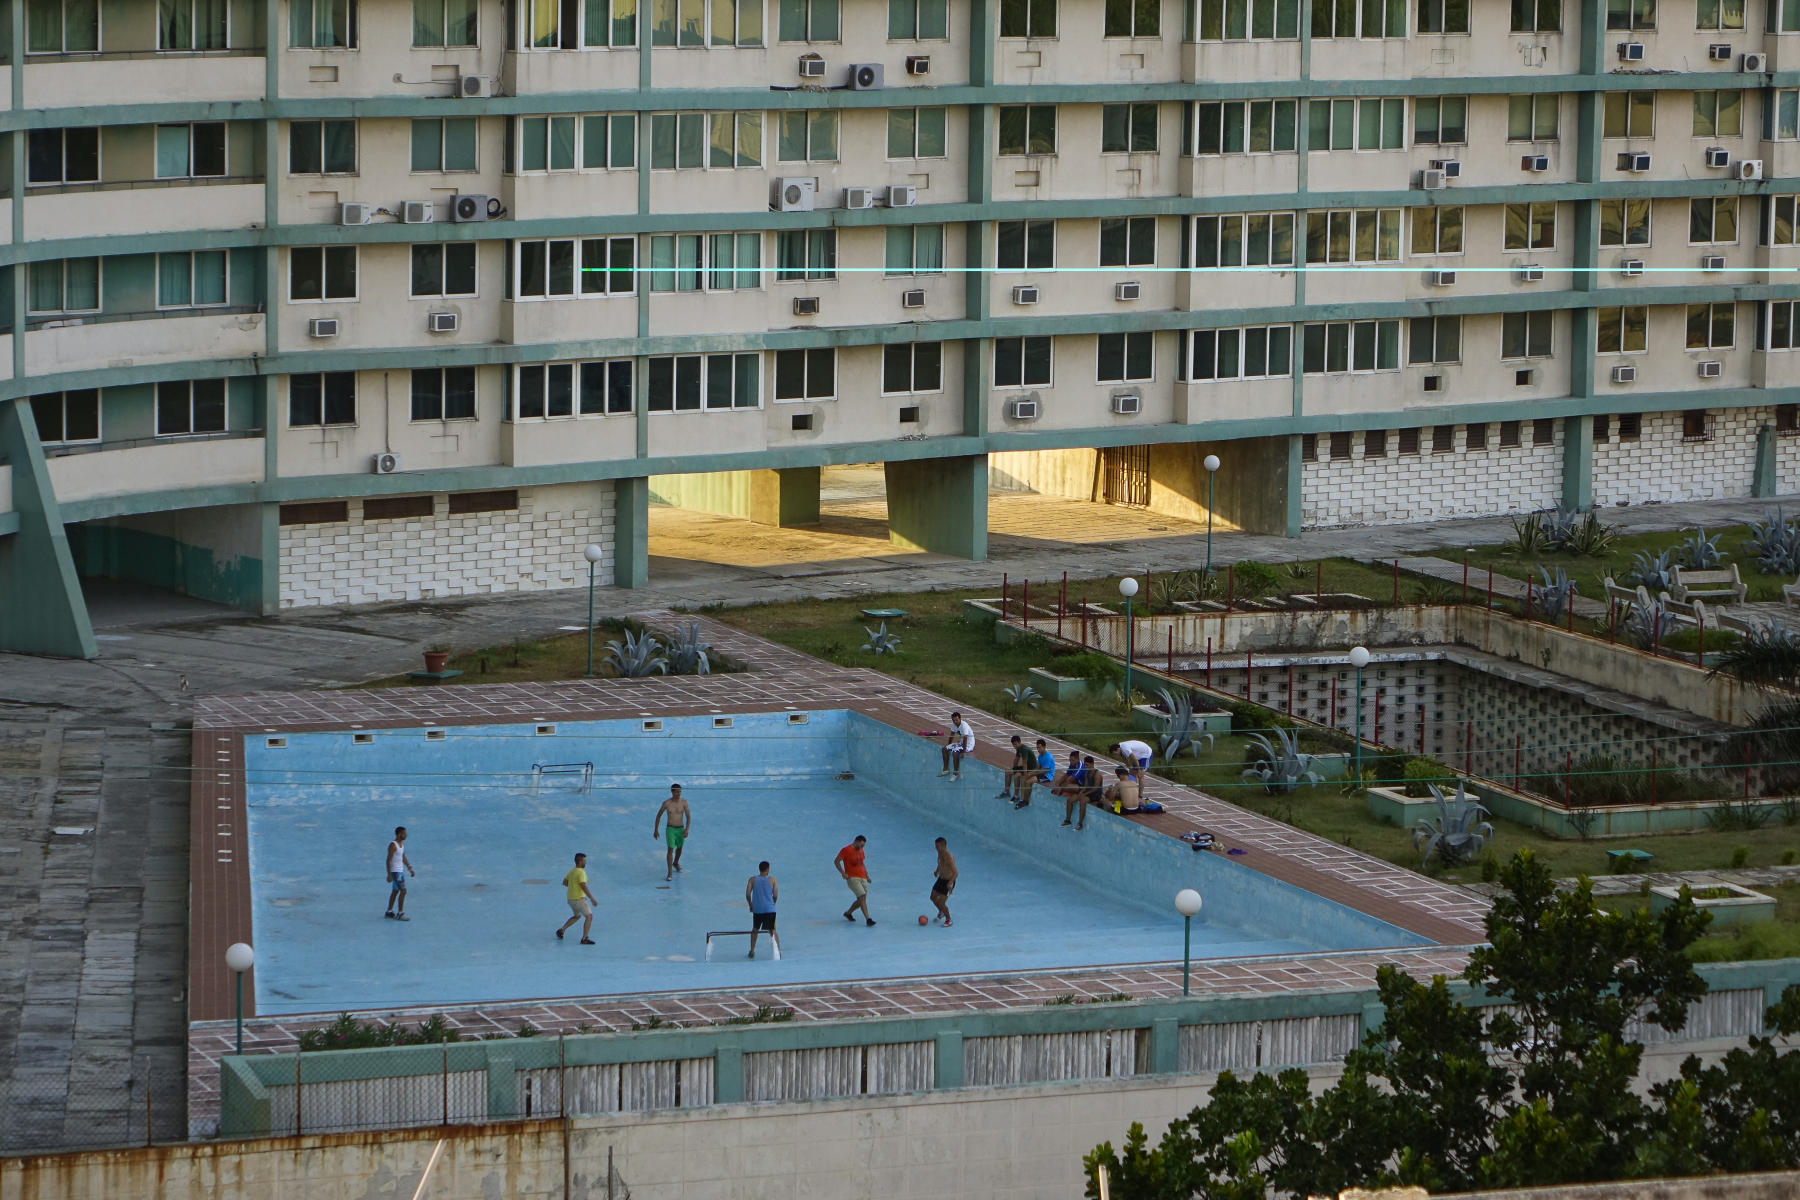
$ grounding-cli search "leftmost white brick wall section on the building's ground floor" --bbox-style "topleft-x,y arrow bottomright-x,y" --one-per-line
281,484 -> 616,608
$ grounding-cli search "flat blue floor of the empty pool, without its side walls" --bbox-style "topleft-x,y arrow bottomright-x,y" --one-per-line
248,775 -> 1319,1015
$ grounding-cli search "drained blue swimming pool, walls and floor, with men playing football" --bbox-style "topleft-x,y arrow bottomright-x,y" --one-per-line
245,711 -> 1429,1015
